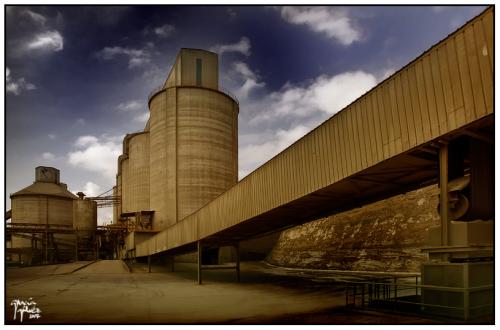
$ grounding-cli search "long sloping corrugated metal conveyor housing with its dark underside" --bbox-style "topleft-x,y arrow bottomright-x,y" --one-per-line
136,8 -> 494,256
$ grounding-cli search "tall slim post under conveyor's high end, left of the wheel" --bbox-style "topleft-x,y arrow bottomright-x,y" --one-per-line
439,145 -> 449,246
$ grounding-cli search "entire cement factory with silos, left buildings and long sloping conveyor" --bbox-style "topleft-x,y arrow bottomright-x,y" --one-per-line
6,8 -> 494,321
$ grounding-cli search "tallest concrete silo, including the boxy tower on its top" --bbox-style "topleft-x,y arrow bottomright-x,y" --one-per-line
147,49 -> 239,230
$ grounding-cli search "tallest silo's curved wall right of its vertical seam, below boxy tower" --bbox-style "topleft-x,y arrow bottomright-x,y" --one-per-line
177,87 -> 238,220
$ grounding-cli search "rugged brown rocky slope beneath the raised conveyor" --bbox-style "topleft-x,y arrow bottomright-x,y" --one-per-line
267,185 -> 439,272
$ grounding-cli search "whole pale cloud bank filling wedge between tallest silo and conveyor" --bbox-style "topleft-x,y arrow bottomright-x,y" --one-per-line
239,66 -> 377,179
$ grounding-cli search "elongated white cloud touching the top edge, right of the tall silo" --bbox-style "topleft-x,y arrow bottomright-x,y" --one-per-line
281,6 -> 361,46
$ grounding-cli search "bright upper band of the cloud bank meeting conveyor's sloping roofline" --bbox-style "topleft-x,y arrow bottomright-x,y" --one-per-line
253,71 -> 377,122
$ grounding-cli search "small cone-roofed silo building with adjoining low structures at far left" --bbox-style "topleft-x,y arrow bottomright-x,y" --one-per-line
5,166 -> 126,266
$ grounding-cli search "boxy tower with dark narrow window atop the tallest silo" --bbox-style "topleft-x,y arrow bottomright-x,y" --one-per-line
163,48 -> 219,90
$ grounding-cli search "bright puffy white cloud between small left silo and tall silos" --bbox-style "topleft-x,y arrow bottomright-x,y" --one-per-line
68,135 -> 122,180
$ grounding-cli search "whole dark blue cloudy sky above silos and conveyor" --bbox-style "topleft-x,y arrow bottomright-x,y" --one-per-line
4,5 -> 485,224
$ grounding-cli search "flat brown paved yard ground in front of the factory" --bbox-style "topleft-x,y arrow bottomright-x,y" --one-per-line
6,260 -> 446,324
